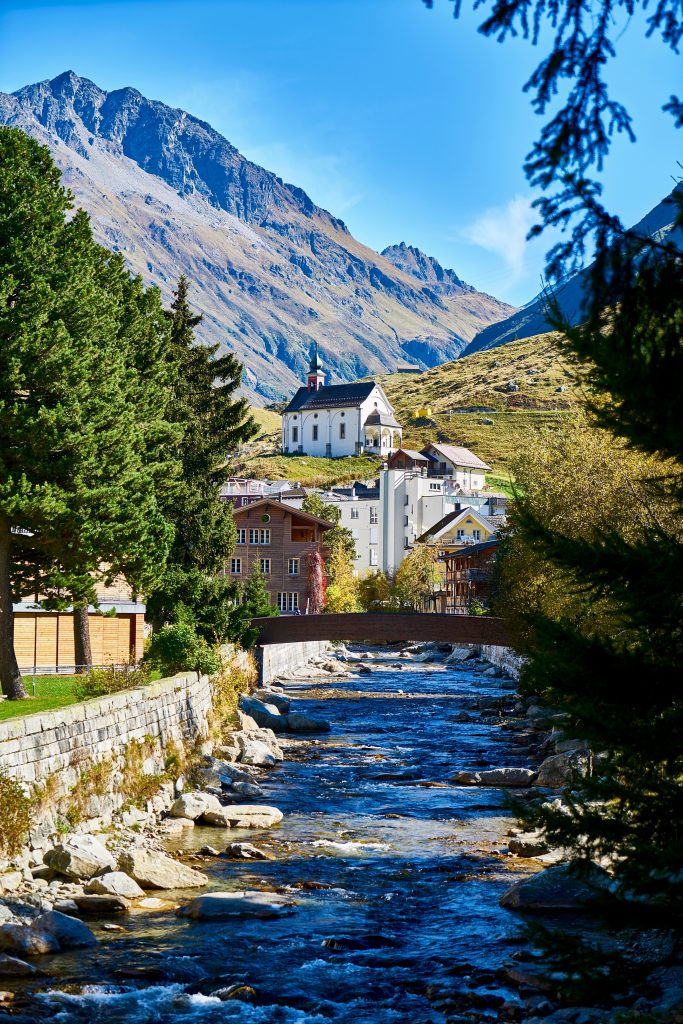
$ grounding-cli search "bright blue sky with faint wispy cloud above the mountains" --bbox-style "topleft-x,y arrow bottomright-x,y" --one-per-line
0,0 -> 683,303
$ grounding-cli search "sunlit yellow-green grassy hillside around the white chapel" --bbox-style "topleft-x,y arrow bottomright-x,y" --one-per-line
238,335 -> 585,489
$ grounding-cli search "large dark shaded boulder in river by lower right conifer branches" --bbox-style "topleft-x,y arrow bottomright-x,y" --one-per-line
500,864 -> 610,911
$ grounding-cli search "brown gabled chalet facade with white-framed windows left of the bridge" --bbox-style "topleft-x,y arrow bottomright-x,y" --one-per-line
225,498 -> 332,613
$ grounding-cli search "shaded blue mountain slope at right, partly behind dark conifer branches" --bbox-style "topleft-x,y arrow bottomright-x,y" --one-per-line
462,189 -> 683,355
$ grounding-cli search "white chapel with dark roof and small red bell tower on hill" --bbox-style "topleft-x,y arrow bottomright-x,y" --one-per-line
283,345 -> 402,459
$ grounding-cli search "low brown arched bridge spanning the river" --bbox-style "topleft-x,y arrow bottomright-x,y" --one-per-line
252,611 -> 510,647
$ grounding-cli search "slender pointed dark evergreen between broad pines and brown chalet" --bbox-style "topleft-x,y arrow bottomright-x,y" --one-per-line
147,276 -> 257,642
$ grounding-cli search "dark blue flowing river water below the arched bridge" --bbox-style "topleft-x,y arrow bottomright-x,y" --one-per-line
7,649 -> 536,1024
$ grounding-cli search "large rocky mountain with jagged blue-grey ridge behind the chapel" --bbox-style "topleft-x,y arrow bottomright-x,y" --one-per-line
0,72 -> 513,402
